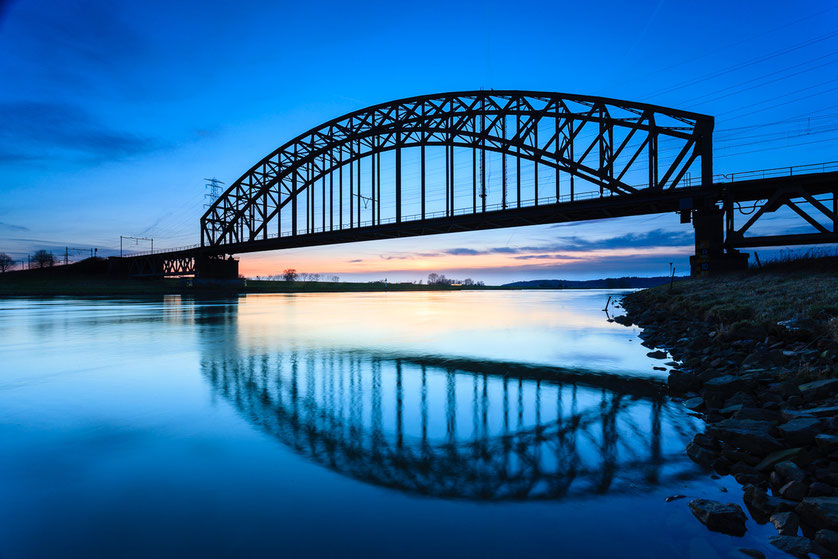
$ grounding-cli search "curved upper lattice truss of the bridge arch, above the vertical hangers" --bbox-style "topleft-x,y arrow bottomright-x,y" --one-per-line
201,91 -> 713,246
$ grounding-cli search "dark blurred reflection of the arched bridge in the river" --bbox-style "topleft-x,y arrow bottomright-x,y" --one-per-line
201,330 -> 697,501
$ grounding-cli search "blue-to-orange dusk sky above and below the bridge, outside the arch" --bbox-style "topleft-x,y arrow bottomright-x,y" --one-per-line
0,0 -> 838,284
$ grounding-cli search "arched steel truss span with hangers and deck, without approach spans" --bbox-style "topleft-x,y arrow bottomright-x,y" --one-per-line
201,91 -> 713,252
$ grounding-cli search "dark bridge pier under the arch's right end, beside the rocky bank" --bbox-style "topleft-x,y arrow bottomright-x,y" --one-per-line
690,204 -> 749,277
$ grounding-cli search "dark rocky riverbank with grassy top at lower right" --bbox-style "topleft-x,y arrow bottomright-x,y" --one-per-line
616,270 -> 838,558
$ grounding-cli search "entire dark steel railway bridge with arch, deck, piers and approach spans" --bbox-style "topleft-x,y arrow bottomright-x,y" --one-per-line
115,90 -> 838,277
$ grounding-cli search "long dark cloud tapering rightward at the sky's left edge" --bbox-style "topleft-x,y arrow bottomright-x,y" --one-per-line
0,101 -> 162,162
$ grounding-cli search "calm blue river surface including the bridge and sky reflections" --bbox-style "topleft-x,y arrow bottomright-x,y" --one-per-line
0,291 -> 776,559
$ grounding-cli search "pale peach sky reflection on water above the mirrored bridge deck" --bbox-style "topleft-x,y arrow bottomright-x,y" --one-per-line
221,290 -> 661,376
